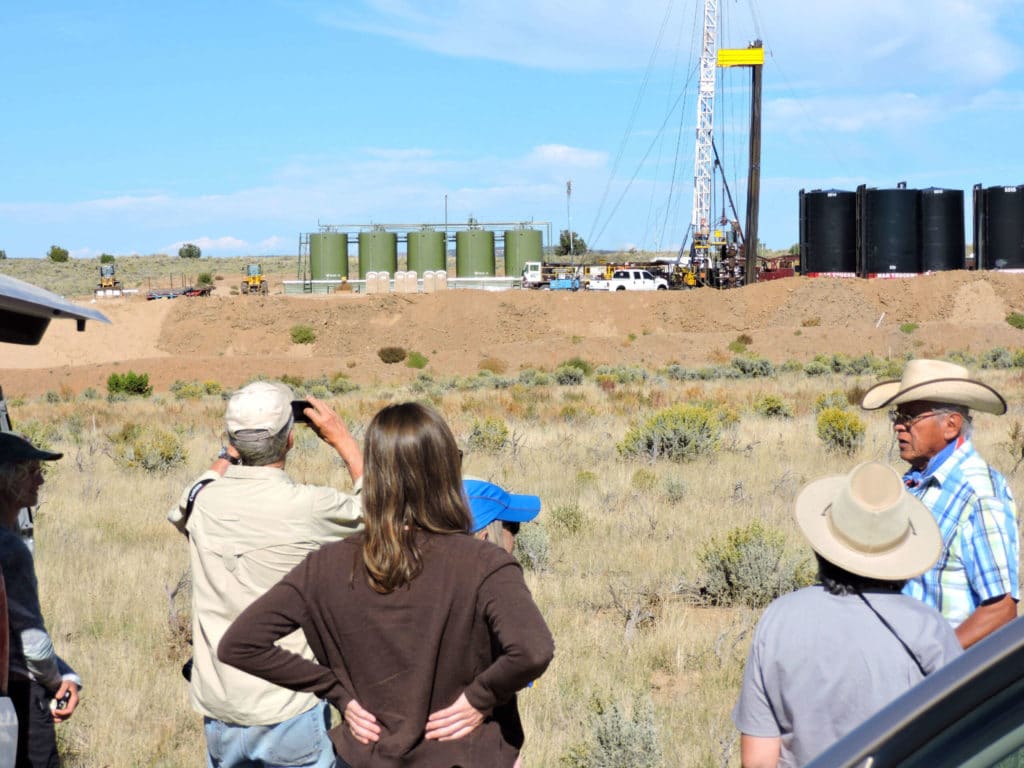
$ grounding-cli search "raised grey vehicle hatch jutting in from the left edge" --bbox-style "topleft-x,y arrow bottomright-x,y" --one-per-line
0,274 -> 110,344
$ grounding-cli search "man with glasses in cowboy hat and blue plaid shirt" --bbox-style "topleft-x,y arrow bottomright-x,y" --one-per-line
861,359 -> 1020,648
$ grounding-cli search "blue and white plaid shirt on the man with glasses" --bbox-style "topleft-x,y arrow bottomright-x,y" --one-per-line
903,440 -> 1020,627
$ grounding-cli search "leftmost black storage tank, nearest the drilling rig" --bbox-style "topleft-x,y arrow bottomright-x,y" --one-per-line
800,189 -> 857,278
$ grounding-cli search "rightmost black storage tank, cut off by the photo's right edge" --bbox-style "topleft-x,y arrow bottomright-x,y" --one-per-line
974,185 -> 1024,269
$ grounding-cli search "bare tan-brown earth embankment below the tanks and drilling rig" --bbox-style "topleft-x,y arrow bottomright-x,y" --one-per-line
0,271 -> 1024,396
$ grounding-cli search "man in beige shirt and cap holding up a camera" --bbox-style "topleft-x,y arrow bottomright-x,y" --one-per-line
168,381 -> 362,768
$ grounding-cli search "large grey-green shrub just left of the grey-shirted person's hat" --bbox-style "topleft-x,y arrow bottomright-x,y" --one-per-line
683,520 -> 814,608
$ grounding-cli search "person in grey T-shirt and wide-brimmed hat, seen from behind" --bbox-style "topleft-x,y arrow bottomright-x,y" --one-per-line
732,462 -> 961,768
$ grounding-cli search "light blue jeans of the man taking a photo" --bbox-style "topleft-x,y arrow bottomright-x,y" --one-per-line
203,701 -> 337,768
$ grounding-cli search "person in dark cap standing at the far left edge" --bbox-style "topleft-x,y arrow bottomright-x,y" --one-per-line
0,432 -> 82,768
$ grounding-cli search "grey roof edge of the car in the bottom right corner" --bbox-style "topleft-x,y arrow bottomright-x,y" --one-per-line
806,617 -> 1024,768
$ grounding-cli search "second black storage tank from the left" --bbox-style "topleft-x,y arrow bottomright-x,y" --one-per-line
857,184 -> 921,278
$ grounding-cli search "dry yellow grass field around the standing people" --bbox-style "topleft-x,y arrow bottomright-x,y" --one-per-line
12,372 -> 1024,767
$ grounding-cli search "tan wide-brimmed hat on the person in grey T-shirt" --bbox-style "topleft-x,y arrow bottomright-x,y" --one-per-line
796,462 -> 942,582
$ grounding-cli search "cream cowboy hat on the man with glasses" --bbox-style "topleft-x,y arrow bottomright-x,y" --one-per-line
860,359 -> 1007,416
